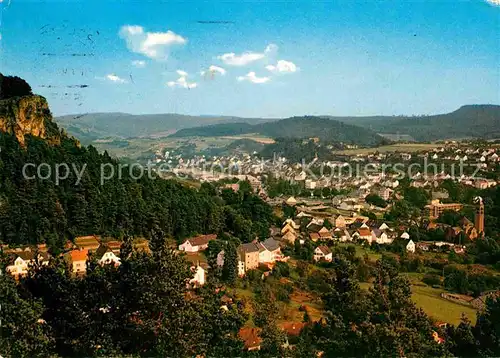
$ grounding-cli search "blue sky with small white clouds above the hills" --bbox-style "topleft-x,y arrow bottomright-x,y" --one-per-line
0,0 -> 500,117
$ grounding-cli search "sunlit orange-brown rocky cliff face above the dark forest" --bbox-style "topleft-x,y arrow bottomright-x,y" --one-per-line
0,95 -> 60,146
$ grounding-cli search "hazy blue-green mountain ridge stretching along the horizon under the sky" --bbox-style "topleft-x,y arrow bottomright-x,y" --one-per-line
55,105 -> 500,142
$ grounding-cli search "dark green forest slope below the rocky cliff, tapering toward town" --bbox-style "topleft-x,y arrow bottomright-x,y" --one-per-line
0,133 -> 272,248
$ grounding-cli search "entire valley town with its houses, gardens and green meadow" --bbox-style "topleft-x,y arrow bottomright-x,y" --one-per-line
3,138 -> 500,350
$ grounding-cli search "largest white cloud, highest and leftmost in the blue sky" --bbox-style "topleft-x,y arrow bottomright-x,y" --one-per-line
119,25 -> 187,60
